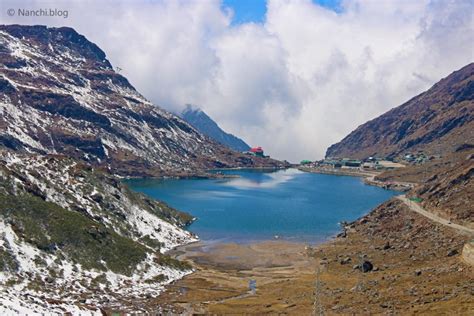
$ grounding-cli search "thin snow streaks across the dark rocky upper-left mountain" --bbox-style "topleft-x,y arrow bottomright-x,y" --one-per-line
0,26 -> 221,170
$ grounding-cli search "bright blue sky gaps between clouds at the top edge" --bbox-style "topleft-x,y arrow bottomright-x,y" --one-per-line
223,0 -> 341,24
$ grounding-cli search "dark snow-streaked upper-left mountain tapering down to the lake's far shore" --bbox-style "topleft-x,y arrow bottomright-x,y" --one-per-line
0,25 -> 282,176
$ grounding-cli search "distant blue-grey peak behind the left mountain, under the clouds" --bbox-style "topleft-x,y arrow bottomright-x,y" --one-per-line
181,105 -> 250,152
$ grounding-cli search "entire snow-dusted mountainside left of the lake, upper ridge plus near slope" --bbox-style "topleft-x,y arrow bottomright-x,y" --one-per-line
0,25 -> 283,315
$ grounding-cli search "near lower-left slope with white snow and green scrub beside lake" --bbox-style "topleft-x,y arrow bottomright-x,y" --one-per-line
0,150 -> 196,314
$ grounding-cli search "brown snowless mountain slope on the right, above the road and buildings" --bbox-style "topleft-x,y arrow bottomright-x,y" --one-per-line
326,63 -> 474,225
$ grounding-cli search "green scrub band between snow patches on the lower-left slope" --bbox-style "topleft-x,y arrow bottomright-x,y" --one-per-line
0,194 -> 147,275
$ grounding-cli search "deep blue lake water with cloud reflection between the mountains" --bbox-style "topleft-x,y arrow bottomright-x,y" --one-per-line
126,169 -> 397,243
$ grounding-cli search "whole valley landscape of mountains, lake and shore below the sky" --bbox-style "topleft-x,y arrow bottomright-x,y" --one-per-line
0,25 -> 474,315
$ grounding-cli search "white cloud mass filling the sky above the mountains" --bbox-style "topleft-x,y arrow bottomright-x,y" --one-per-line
2,0 -> 474,160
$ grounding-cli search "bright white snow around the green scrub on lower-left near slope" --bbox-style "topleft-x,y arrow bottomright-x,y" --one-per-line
0,152 -> 197,315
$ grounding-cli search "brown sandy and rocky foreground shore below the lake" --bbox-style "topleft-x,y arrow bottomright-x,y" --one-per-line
154,200 -> 474,315
